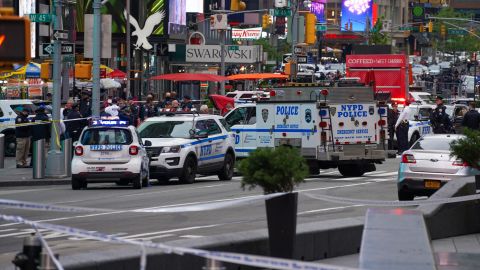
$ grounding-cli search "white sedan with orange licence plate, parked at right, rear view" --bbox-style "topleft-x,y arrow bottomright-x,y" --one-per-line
397,134 -> 480,201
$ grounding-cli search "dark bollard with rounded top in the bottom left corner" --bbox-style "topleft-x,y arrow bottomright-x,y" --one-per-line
12,233 -> 42,270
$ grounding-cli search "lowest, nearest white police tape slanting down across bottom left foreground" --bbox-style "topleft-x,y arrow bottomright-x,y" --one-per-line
0,214 -> 356,270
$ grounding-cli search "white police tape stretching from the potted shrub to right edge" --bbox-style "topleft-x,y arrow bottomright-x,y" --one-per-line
304,193 -> 480,207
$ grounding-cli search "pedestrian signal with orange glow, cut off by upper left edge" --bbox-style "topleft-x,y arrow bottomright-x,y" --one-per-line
0,16 -> 31,65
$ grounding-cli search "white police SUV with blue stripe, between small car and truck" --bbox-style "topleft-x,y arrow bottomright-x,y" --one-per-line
138,112 -> 235,184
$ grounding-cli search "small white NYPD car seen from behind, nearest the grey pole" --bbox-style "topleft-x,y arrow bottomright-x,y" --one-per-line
72,119 -> 149,190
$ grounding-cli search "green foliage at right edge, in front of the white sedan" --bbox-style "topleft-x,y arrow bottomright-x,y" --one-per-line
450,129 -> 480,169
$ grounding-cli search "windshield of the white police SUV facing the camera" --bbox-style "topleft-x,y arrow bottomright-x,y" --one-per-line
139,121 -> 193,139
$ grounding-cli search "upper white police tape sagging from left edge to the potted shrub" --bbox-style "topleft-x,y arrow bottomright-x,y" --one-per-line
0,193 -> 284,213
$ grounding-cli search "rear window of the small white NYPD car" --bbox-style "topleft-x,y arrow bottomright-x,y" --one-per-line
81,128 -> 132,145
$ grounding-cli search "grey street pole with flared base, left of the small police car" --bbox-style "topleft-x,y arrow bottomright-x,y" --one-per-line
45,0 -> 65,178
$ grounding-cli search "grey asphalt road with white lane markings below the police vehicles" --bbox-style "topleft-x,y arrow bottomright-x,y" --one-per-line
0,158 -> 399,265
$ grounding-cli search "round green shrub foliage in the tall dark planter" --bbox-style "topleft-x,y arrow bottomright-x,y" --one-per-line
238,146 -> 308,194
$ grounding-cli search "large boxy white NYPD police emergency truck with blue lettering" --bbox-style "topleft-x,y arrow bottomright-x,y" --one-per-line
226,85 -> 387,177
